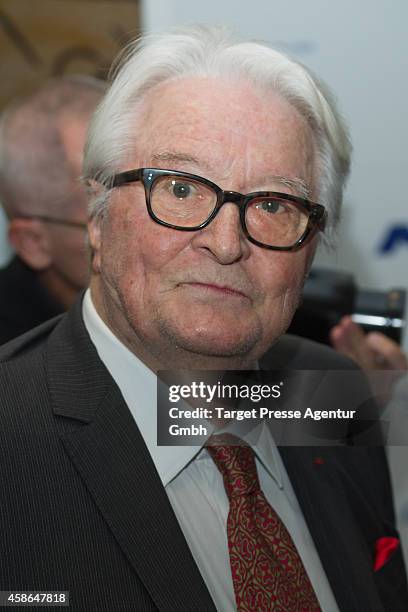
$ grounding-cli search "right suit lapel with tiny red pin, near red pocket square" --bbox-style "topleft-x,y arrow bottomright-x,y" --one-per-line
279,447 -> 383,612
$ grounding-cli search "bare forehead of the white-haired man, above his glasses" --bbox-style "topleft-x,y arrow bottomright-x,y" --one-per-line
126,78 -> 314,190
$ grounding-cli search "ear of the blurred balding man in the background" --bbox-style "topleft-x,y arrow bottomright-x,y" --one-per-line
8,217 -> 52,272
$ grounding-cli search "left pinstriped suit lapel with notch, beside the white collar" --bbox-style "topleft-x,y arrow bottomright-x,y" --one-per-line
47,305 -> 215,612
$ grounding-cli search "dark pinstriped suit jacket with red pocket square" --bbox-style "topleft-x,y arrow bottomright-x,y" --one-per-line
0,303 -> 408,612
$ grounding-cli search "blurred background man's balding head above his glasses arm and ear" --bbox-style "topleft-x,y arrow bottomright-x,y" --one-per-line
0,76 -> 105,218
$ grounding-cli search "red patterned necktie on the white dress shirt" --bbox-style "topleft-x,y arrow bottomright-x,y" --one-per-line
207,434 -> 321,612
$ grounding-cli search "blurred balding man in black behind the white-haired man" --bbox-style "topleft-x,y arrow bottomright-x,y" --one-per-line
0,76 -> 105,343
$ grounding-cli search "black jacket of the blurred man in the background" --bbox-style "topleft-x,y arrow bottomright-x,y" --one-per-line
0,257 -> 64,344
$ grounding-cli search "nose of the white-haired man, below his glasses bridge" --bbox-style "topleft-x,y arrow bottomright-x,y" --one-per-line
192,202 -> 250,265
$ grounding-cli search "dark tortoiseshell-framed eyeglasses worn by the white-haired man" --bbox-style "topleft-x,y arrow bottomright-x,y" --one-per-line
110,168 -> 327,251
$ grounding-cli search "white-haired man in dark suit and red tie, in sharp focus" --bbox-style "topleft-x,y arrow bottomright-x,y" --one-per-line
0,28 -> 408,612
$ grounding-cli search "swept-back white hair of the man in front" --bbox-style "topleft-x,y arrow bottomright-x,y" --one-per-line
83,26 -> 351,243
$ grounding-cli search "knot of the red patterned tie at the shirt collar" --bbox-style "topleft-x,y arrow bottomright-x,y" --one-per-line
207,434 -> 260,500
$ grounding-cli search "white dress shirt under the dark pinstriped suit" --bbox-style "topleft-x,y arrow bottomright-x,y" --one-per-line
83,290 -> 338,612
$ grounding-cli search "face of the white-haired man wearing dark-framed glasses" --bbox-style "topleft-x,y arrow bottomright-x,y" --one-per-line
90,78 -> 314,368
